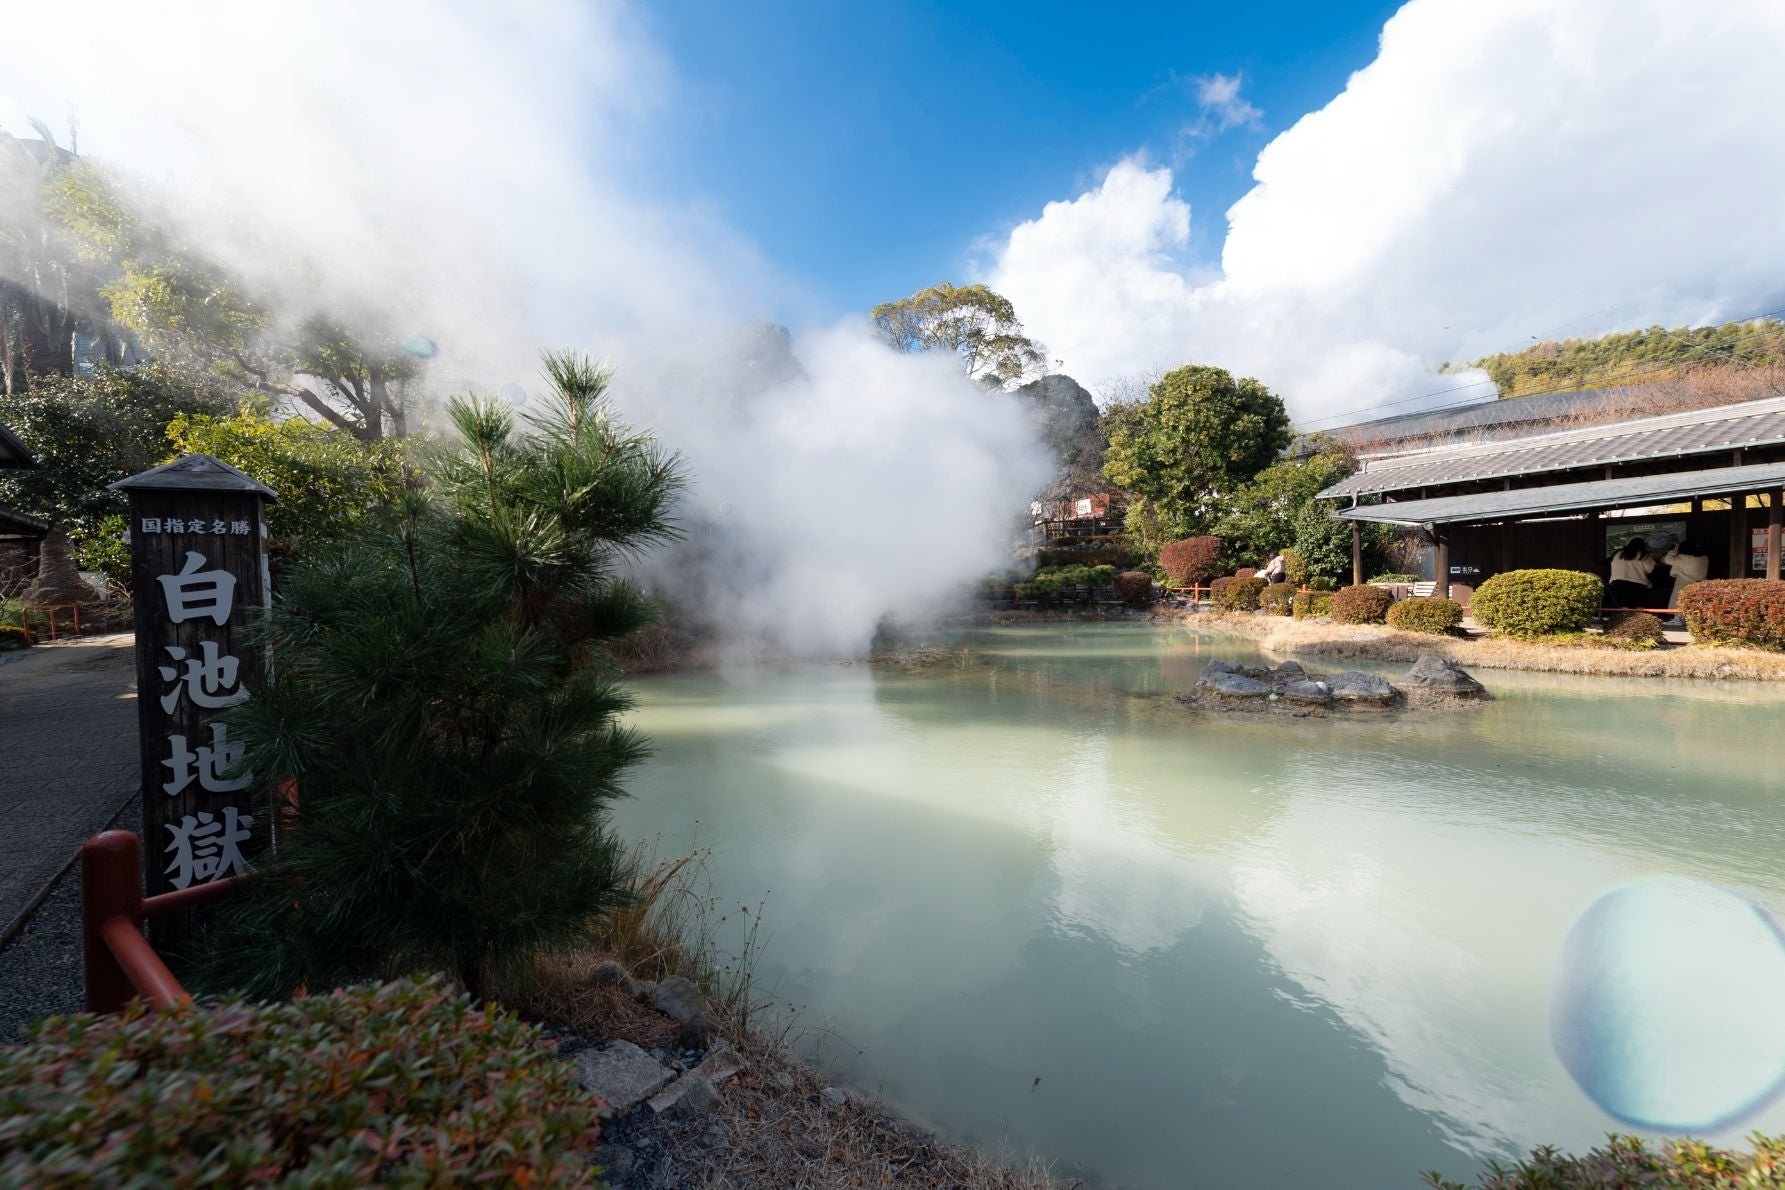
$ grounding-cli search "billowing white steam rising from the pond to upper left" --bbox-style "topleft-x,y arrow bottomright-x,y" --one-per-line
0,0 -> 1048,653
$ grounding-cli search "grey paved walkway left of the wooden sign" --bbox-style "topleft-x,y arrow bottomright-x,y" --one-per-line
0,633 -> 139,940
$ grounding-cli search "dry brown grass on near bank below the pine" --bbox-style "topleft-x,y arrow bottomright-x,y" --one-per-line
502,846 -> 1078,1190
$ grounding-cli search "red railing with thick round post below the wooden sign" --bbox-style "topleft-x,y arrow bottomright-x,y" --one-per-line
80,831 -> 245,1013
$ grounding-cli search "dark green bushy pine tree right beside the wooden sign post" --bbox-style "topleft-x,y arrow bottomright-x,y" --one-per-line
202,353 -> 682,996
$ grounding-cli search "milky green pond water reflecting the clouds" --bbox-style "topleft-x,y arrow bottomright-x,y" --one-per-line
618,624 -> 1785,1190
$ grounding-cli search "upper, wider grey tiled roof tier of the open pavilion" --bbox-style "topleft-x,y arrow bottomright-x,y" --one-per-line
1321,396 -> 1785,498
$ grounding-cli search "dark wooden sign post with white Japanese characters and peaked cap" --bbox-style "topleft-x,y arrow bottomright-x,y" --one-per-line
112,455 -> 275,951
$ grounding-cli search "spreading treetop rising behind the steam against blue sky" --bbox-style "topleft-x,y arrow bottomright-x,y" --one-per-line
869,282 -> 1048,389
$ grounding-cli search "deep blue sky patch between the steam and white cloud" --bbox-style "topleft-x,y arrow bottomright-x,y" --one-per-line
644,0 -> 1398,314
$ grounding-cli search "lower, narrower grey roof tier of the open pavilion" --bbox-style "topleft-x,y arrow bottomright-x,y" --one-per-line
1335,462 -> 1785,525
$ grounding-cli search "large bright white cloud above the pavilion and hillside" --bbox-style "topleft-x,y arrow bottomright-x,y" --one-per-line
985,0 -> 1785,421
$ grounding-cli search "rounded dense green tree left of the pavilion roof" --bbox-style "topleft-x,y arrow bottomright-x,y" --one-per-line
1103,364 -> 1291,548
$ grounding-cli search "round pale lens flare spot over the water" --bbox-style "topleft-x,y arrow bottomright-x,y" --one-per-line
1549,876 -> 1785,1131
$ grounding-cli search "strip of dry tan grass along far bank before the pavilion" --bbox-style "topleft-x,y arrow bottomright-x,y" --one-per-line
1194,612 -> 1785,682
